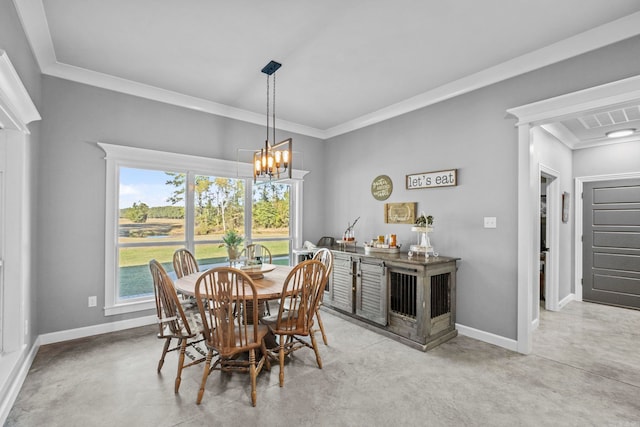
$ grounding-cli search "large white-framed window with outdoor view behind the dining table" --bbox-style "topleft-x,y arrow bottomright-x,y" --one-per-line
99,143 -> 302,315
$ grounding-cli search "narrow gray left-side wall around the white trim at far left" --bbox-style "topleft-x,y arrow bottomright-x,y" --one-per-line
0,0 -> 42,352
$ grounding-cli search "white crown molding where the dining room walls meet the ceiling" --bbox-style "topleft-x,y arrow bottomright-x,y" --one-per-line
13,0 -> 640,139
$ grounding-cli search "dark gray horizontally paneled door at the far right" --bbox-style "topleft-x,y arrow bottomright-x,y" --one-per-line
582,179 -> 640,309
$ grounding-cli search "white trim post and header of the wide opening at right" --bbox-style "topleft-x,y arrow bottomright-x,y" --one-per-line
507,75 -> 640,354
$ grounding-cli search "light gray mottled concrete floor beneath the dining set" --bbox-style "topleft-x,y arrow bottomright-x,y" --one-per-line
6,302 -> 640,427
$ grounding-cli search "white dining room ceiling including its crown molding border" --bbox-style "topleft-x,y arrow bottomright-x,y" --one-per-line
14,0 -> 640,140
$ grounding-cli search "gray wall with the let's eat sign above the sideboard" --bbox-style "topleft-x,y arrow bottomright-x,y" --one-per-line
325,37 -> 640,339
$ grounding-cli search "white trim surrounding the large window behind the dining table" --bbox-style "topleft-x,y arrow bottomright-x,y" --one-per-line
98,142 -> 308,316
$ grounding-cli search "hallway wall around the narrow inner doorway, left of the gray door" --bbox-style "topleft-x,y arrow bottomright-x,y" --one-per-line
532,127 -> 575,304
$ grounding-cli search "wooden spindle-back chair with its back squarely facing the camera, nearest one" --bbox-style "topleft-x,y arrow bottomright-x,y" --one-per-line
195,267 -> 271,406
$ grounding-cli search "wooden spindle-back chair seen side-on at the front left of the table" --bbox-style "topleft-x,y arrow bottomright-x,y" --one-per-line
149,259 -> 205,393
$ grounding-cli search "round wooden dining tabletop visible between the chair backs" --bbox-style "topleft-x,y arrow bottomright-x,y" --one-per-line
174,264 -> 293,301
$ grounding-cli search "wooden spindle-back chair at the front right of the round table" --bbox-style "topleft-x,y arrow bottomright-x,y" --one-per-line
262,260 -> 327,387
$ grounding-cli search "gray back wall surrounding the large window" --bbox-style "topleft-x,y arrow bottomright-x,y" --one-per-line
38,76 -> 323,333
